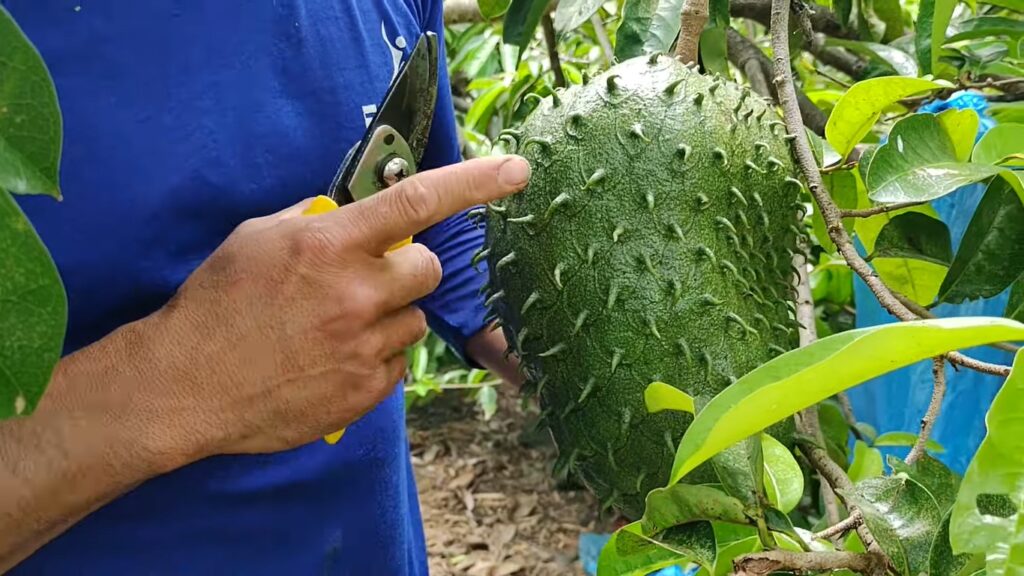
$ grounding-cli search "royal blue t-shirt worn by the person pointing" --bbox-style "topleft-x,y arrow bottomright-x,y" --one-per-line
6,0 -> 485,576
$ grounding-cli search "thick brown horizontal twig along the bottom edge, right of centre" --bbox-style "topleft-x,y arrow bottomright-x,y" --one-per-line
732,550 -> 886,576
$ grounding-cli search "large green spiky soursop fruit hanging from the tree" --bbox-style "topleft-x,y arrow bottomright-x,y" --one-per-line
485,56 -> 801,518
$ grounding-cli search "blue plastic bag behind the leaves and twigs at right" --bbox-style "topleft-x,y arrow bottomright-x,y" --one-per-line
848,92 -> 1013,474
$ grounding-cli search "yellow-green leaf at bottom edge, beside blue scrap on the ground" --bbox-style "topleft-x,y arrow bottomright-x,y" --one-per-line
597,522 -> 716,576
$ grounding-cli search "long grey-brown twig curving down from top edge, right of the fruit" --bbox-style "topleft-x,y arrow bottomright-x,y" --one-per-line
771,0 -> 1010,376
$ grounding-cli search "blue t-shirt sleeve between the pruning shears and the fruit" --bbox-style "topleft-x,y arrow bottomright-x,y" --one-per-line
414,0 -> 488,367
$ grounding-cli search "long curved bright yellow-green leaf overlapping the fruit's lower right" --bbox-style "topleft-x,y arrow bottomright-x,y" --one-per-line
671,317 -> 1024,484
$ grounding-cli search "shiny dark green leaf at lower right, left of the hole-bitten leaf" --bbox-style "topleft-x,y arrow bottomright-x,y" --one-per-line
837,475 -> 942,576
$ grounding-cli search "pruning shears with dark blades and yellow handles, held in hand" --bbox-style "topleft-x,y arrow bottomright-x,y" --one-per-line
303,32 -> 438,444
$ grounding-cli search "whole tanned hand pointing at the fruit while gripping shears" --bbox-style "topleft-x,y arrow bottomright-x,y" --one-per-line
138,157 -> 529,461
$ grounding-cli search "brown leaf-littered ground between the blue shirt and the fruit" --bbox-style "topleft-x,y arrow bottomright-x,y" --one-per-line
409,387 -> 616,576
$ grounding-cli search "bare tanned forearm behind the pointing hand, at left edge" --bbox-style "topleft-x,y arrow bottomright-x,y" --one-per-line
0,315 -> 180,573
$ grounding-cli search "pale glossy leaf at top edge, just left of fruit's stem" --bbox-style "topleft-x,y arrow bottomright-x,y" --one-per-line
615,0 -> 683,60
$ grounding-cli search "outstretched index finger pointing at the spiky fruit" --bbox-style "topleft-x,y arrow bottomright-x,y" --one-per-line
328,155 -> 530,255
